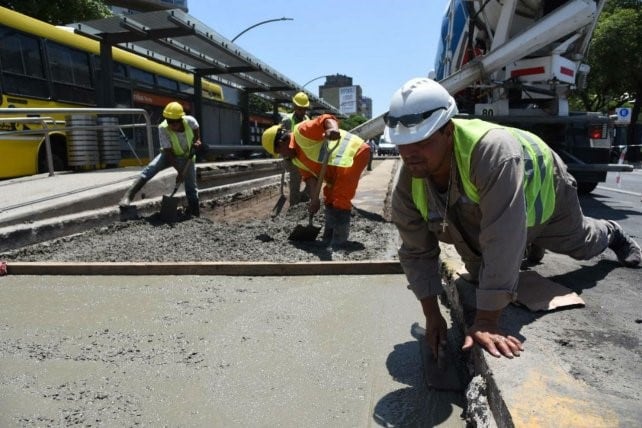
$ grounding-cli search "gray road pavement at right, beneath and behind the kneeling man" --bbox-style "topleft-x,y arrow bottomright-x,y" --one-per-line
464,170 -> 642,427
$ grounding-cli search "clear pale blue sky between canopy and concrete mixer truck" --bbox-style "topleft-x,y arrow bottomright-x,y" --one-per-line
187,0 -> 448,117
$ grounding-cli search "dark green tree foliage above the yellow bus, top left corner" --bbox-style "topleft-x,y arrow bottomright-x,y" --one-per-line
0,0 -> 111,25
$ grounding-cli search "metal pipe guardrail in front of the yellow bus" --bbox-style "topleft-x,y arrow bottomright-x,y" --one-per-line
0,108 -> 154,176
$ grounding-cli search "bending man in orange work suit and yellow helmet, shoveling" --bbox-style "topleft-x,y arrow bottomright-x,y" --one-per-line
261,114 -> 370,249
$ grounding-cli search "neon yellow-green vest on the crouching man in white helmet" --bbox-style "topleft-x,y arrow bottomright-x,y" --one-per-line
412,119 -> 555,227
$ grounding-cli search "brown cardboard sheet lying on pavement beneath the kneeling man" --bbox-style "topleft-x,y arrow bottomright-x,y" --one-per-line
517,271 -> 585,312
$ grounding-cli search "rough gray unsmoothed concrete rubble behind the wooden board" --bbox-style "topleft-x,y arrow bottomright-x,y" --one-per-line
0,188 -> 398,262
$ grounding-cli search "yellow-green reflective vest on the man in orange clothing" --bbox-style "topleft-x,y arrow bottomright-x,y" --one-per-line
292,125 -> 363,175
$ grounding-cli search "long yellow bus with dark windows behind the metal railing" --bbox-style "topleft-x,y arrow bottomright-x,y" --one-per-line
0,7 -> 223,179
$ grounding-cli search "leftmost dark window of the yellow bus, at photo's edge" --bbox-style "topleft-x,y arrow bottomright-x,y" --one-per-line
0,27 -> 49,98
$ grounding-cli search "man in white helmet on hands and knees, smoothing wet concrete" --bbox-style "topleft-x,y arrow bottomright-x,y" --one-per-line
384,78 -> 641,358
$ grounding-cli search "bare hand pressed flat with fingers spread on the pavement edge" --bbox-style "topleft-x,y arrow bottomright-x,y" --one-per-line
462,309 -> 524,358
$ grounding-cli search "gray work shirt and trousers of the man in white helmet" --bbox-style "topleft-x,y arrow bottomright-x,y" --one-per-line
392,123 -> 609,310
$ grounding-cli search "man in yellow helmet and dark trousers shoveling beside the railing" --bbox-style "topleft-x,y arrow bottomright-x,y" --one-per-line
118,101 -> 202,217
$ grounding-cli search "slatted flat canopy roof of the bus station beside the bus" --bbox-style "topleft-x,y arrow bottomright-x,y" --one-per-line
69,9 -> 339,114
